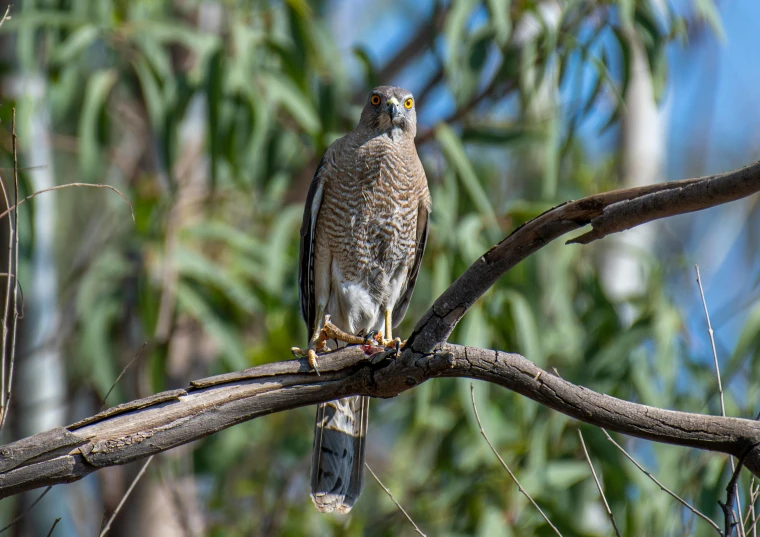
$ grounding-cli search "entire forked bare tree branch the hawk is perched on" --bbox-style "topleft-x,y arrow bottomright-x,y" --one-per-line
0,158 -> 760,498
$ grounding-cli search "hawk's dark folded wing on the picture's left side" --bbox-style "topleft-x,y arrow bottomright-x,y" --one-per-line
298,154 -> 326,337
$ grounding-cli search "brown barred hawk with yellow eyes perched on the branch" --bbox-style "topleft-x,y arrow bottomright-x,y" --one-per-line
294,86 -> 430,513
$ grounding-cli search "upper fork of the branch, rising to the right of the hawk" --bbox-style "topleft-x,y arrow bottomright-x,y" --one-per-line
408,157 -> 760,353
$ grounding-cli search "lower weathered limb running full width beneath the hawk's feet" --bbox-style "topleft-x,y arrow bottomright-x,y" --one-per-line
0,344 -> 760,498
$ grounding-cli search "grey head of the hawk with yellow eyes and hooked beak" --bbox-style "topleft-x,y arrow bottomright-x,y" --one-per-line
359,86 -> 417,138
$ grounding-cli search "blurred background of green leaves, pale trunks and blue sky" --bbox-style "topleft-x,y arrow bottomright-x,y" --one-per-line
0,0 -> 760,537
